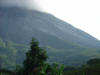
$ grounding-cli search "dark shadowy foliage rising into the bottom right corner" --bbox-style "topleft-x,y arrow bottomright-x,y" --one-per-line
64,58 -> 100,75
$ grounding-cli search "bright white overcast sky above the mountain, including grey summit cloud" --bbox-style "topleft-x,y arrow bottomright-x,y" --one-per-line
0,0 -> 100,40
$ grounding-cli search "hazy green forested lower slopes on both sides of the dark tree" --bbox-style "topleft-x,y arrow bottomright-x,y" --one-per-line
0,38 -> 100,69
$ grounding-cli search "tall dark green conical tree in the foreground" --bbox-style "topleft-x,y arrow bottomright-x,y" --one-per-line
24,38 -> 47,75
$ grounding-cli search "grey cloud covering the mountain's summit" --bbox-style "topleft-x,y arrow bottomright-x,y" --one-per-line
0,0 -> 41,10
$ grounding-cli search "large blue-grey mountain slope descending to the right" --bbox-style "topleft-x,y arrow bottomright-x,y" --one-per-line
0,7 -> 100,68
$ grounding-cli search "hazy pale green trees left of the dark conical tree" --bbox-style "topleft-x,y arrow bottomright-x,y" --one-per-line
0,38 -> 28,69
